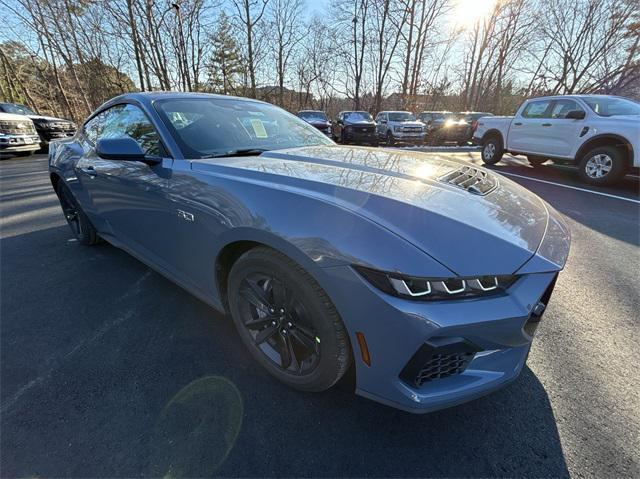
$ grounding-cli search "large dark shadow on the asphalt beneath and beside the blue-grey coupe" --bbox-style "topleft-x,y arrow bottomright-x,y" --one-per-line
0,225 -> 568,477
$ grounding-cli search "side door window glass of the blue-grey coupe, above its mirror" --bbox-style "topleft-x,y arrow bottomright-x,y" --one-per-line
99,104 -> 162,156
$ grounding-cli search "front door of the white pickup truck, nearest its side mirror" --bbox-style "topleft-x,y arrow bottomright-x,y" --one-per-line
540,98 -> 586,157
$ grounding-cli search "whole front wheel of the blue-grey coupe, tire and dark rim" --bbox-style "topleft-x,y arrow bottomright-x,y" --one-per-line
227,247 -> 351,392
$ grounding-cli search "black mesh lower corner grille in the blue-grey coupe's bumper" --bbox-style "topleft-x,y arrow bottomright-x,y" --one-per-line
400,337 -> 481,388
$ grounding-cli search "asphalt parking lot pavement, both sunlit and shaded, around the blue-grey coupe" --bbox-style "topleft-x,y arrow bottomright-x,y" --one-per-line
0,153 -> 640,478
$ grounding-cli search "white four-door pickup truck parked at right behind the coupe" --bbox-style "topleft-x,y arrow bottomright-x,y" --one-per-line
473,95 -> 640,185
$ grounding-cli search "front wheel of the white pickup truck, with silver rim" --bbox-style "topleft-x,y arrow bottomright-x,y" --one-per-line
578,146 -> 627,185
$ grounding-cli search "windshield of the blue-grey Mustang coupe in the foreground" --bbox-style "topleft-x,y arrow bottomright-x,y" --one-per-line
155,98 -> 333,158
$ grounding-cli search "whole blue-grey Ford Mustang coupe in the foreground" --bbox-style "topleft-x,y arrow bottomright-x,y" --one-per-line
49,93 -> 569,412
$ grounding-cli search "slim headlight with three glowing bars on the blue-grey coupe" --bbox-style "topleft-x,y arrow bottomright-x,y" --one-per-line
354,266 -> 518,301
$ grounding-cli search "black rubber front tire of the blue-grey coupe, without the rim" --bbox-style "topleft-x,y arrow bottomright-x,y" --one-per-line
227,248 -> 347,391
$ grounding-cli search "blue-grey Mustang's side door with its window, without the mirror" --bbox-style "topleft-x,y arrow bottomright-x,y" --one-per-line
76,103 -> 176,268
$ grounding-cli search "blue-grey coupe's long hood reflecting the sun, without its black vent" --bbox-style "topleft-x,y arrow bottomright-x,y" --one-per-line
192,145 -> 564,276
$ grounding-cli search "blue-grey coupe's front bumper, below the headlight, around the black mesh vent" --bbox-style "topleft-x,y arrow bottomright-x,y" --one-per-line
323,266 -> 557,413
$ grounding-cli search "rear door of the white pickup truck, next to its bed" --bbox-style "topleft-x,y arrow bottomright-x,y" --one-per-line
507,99 -> 552,153
